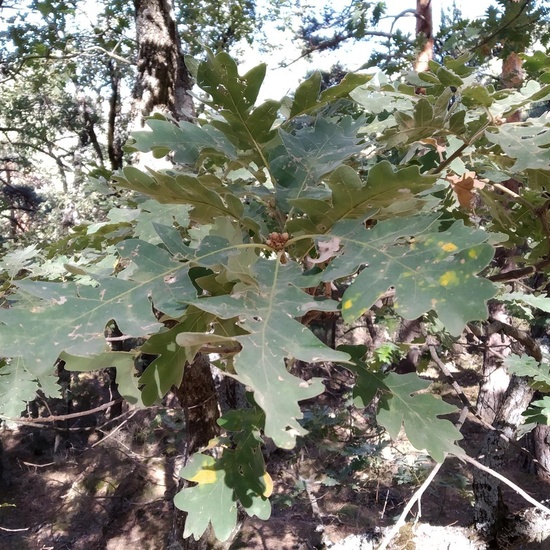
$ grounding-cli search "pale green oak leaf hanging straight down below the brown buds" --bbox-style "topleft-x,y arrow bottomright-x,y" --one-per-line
185,259 -> 348,449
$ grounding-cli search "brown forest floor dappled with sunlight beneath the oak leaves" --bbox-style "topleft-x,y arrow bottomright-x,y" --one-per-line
0,366 -> 550,550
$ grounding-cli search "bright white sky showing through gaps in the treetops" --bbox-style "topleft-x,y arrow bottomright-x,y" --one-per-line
250,0 -> 500,100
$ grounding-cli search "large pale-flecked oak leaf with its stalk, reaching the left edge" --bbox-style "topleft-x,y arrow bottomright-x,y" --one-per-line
0,236 -> 226,376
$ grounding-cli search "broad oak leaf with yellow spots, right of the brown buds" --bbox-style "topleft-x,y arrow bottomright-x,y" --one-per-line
319,215 -> 496,335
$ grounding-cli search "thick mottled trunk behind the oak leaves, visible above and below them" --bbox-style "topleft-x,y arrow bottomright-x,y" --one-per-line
132,5 -> 219,550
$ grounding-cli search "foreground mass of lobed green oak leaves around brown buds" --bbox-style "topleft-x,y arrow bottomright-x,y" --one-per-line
5,40 -> 550,539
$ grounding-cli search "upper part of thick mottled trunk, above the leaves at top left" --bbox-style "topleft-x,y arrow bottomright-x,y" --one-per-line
133,0 -> 194,128
